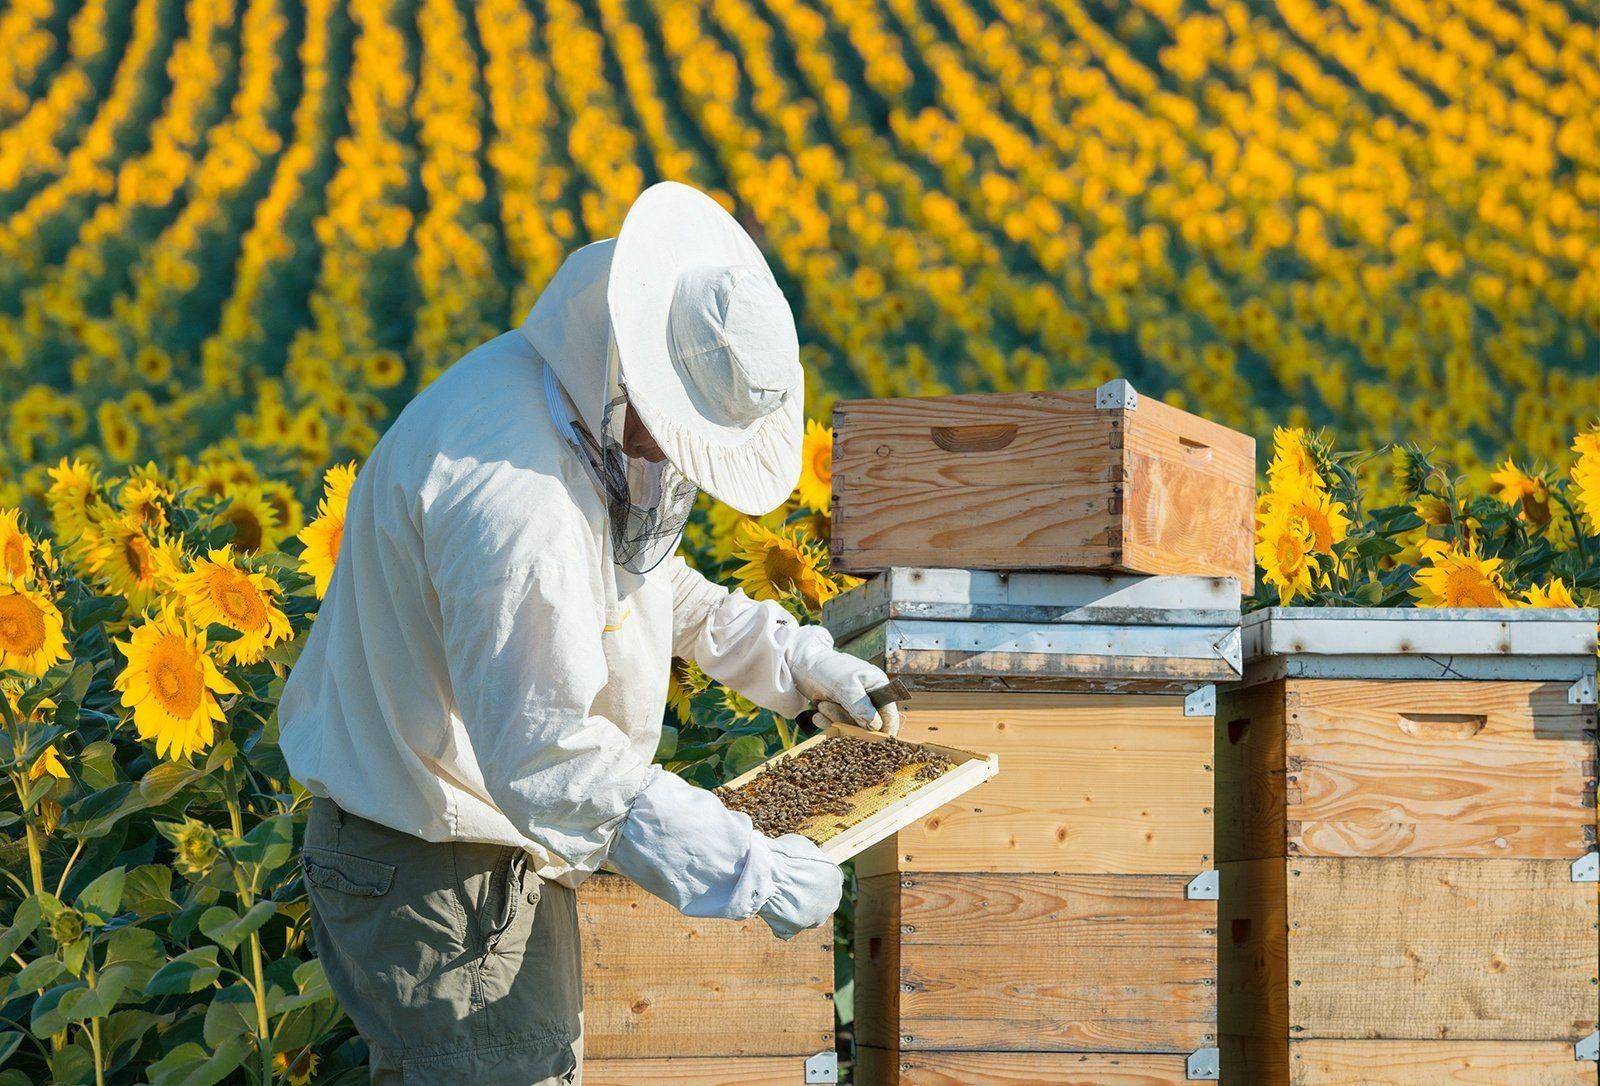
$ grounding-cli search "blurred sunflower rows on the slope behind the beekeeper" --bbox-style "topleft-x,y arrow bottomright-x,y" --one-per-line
0,0 -> 1600,504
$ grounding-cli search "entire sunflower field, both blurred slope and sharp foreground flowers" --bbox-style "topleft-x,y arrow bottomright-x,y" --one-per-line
0,0 -> 1600,1086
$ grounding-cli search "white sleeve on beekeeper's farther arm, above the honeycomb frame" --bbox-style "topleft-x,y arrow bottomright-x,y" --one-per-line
672,557 -> 834,717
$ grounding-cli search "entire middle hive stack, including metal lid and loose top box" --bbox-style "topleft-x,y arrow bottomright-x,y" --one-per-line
824,381 -> 1254,1086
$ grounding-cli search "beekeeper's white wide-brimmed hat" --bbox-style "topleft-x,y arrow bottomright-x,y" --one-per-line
606,181 -> 805,517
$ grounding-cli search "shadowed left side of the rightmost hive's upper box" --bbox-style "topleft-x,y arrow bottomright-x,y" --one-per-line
1216,683 -> 1286,864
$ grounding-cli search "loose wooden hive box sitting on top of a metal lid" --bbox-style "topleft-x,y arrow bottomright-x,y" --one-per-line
832,381 -> 1256,590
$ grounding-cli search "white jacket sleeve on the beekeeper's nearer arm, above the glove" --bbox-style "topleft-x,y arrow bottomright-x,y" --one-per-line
429,508 -> 650,867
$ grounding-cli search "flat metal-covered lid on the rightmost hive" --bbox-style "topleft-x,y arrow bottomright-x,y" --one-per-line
1243,608 -> 1600,685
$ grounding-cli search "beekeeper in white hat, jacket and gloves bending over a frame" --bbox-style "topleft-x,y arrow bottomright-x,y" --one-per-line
280,184 -> 896,1086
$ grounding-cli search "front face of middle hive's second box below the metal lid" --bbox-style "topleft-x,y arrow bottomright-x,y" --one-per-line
899,873 -> 1216,1054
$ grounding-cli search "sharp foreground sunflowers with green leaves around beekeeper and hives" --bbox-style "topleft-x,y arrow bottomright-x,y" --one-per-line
0,412 -> 1600,1086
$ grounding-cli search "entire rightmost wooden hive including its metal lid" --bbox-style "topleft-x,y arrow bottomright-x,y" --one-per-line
1216,608 -> 1600,1086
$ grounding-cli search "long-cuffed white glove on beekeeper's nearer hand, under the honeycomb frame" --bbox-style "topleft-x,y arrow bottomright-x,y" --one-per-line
610,766 -> 843,939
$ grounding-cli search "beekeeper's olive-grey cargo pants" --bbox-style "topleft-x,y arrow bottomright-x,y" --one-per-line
301,798 -> 582,1086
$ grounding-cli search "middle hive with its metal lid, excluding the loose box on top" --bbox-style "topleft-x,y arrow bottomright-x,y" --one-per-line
824,569 -> 1240,1086
